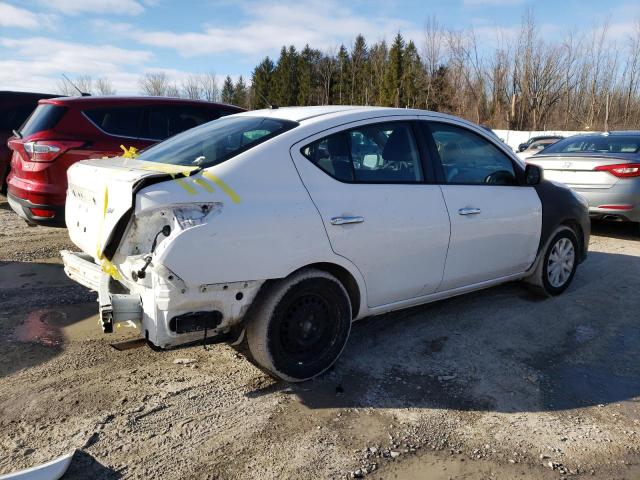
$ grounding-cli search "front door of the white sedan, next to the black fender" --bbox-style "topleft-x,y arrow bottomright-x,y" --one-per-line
428,122 -> 542,291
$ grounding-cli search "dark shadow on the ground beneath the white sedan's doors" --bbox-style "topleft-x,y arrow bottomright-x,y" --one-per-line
247,252 -> 640,412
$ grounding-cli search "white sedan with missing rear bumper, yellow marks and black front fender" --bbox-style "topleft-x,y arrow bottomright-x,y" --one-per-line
62,106 -> 589,381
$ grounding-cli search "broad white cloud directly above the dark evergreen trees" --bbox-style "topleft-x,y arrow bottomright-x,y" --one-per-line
129,0 -> 421,58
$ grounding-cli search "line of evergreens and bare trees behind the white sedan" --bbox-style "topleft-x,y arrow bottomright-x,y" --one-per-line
247,12 -> 640,130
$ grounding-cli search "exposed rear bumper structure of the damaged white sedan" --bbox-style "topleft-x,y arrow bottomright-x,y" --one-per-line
60,250 -> 263,348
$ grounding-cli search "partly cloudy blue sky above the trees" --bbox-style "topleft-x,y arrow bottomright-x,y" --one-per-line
0,0 -> 640,94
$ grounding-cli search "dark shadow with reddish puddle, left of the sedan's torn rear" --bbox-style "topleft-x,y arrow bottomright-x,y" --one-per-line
0,262 -> 96,378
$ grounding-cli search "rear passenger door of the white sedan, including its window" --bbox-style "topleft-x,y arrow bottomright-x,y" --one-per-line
291,117 -> 449,307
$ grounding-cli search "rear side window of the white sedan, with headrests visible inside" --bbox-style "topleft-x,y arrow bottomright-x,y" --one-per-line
301,122 -> 423,183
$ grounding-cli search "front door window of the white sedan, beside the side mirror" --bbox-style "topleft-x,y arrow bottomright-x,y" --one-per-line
430,122 -> 516,185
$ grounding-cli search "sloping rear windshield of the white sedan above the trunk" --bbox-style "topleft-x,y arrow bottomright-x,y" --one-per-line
138,116 -> 298,167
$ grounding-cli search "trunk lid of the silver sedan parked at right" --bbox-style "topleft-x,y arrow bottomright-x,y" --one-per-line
527,153 -> 637,189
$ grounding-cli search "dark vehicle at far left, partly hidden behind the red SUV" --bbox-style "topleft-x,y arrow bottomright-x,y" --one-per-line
0,92 -> 57,193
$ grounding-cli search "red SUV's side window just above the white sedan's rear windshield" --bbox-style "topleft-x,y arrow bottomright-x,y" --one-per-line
140,106 -> 211,140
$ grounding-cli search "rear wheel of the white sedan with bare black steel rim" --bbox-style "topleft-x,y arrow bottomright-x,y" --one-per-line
247,269 -> 351,382
